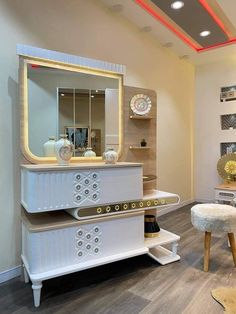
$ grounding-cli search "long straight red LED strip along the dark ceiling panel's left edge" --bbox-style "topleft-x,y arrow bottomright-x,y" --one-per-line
135,0 -> 201,51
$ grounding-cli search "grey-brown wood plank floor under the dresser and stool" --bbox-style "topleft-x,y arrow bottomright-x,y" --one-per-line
0,206 -> 236,314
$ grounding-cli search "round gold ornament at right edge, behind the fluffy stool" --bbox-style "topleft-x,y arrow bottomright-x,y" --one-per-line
217,153 -> 236,182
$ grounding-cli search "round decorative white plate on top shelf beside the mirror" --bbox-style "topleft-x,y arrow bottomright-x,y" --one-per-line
130,94 -> 152,116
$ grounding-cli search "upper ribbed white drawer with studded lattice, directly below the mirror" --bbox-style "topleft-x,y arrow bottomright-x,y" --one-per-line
21,167 -> 143,213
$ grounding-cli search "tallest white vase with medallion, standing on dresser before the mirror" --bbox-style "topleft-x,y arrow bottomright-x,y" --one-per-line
55,134 -> 73,165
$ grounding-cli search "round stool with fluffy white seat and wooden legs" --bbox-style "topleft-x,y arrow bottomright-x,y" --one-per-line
191,204 -> 236,271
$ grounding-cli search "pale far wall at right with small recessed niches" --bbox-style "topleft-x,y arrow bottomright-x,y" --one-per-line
195,59 -> 236,200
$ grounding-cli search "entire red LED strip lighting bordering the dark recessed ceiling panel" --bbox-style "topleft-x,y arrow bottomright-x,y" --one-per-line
135,0 -> 236,52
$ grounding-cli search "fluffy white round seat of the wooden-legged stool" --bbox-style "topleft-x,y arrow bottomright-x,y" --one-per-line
191,204 -> 236,233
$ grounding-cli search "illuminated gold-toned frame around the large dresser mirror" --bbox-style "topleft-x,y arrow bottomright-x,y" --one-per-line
19,56 -> 123,164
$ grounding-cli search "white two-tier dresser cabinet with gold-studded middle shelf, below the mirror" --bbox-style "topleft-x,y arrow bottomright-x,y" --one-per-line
22,163 -> 180,307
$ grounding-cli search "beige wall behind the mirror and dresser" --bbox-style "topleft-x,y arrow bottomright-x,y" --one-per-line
0,0 -> 194,272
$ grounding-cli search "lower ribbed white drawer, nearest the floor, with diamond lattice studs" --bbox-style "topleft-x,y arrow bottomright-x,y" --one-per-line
22,214 -> 144,274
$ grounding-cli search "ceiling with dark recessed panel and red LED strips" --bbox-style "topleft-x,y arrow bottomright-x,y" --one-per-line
101,0 -> 236,64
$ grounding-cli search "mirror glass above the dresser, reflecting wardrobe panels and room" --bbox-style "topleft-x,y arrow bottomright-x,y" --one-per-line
27,64 -> 119,157
